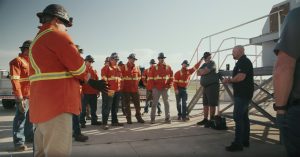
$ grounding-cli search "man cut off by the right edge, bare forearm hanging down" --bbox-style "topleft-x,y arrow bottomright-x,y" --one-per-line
273,7 -> 300,157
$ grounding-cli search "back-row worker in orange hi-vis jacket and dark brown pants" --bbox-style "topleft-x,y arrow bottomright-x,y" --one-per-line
121,53 -> 145,124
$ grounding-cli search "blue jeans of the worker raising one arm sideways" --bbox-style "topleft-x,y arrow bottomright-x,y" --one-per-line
176,87 -> 188,118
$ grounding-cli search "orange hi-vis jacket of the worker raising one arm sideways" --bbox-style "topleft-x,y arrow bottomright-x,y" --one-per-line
173,62 -> 201,90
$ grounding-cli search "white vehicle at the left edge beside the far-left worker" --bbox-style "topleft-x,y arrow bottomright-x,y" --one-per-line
0,69 -> 15,109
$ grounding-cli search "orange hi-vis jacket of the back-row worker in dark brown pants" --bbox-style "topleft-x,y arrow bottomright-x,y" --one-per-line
121,62 -> 141,92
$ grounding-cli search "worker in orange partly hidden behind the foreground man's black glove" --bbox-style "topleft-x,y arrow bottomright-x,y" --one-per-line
80,55 -> 102,128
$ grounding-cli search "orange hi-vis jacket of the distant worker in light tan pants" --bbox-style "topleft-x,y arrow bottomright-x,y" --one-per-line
148,63 -> 173,90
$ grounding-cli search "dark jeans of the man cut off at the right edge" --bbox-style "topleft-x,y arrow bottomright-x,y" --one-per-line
277,104 -> 300,157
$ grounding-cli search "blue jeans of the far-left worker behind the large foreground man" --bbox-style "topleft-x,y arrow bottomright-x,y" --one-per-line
13,100 -> 34,146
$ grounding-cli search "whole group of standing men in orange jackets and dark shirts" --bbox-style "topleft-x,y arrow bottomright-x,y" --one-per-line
10,4 -> 299,156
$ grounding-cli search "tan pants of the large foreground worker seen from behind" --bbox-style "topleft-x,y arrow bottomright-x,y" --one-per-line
34,113 -> 72,157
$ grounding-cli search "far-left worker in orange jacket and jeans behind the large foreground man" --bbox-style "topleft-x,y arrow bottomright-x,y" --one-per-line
9,40 -> 33,151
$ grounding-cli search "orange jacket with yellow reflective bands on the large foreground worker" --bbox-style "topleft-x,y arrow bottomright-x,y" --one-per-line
29,24 -> 87,123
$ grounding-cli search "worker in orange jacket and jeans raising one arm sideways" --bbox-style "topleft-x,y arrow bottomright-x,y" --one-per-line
173,59 -> 202,121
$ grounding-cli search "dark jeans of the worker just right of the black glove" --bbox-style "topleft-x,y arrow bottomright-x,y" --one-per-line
102,92 -> 120,125
